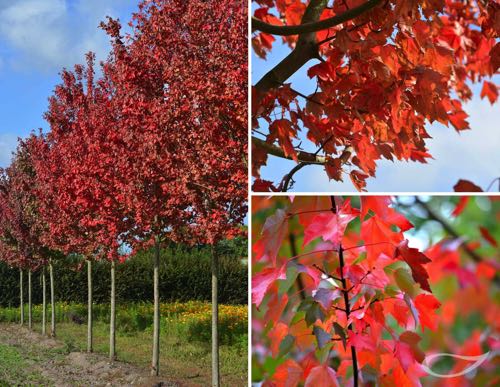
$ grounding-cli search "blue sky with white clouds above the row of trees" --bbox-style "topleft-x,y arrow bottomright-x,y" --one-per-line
0,0 -> 139,167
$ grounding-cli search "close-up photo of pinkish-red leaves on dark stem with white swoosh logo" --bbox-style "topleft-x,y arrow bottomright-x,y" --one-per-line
252,196 -> 500,387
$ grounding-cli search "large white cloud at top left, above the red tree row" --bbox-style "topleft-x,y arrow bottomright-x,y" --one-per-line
0,0 -> 137,71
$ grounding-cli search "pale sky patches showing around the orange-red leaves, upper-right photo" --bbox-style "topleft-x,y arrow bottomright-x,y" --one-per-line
252,39 -> 500,192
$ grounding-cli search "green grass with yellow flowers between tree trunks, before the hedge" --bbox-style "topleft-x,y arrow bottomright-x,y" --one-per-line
0,302 -> 248,386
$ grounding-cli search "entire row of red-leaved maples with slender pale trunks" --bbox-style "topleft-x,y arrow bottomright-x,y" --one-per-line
0,0 -> 248,384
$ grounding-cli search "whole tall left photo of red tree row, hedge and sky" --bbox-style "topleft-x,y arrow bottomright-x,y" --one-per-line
0,0 -> 248,387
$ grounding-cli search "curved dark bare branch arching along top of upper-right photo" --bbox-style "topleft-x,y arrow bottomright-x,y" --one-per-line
252,0 -> 381,36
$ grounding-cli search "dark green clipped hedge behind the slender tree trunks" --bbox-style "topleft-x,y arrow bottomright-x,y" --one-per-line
0,239 -> 248,307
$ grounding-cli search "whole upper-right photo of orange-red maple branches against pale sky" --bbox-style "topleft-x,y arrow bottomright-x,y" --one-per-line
251,0 -> 500,193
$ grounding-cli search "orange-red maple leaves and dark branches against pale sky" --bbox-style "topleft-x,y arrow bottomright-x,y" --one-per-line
252,0 -> 500,192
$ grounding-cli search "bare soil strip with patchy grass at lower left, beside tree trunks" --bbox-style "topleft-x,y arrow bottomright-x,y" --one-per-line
0,324 -> 185,387
